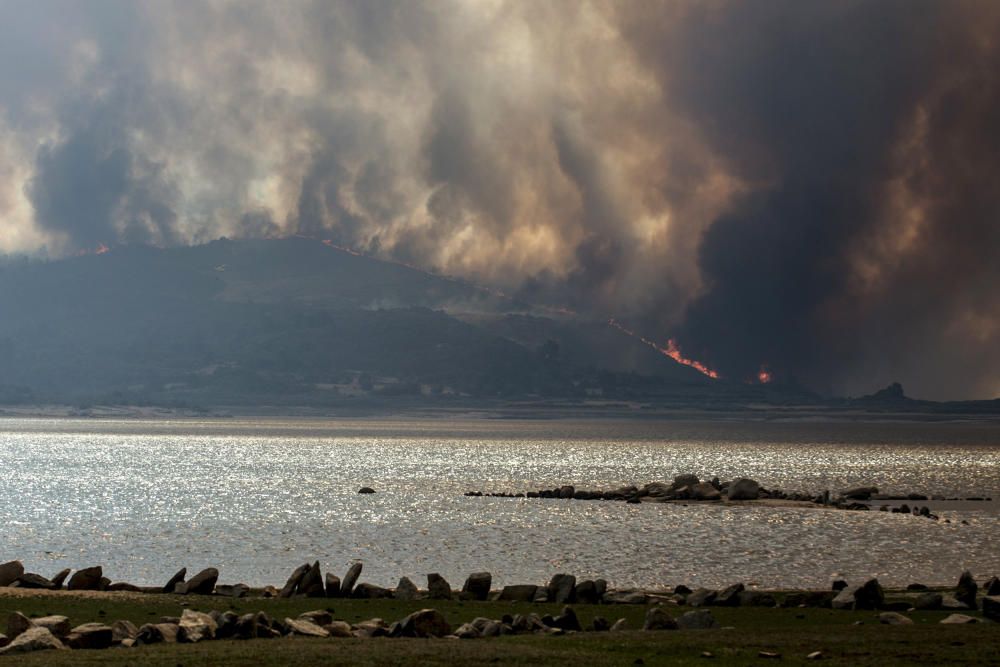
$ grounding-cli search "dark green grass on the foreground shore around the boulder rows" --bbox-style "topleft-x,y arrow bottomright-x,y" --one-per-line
0,595 -> 1000,667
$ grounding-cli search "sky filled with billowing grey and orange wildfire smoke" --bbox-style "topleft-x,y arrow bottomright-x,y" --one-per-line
0,0 -> 1000,398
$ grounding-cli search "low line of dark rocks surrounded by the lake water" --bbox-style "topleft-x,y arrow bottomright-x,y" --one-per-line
465,474 -> 990,520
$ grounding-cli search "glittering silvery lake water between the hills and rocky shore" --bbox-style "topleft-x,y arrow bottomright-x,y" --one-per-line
0,418 -> 1000,588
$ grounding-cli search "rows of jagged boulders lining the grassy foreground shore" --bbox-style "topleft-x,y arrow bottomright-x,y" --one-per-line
0,561 -> 1000,655
